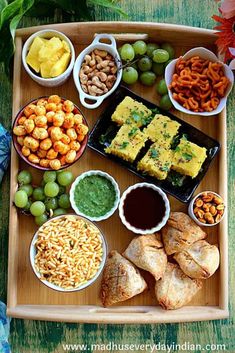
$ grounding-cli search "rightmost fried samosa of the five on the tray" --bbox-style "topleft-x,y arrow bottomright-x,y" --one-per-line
174,240 -> 220,279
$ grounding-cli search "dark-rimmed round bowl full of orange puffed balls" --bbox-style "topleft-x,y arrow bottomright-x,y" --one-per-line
13,95 -> 88,170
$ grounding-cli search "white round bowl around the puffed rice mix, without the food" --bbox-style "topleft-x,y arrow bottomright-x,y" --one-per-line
29,214 -> 108,292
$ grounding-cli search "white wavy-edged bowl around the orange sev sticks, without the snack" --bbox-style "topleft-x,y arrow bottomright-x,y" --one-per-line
165,47 -> 234,116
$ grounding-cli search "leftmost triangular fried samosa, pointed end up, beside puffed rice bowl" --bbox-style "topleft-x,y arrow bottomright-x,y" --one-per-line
101,250 -> 147,306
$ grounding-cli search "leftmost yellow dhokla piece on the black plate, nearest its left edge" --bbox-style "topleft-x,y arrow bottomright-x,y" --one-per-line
105,124 -> 147,162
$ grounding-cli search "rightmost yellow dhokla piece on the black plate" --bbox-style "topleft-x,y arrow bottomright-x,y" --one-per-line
172,138 -> 207,178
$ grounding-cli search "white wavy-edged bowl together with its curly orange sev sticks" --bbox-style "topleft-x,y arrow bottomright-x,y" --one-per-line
165,47 -> 234,116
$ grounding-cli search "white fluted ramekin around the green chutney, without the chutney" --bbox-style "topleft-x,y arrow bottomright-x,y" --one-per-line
69,170 -> 120,222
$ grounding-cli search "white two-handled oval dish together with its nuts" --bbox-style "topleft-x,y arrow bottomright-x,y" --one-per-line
73,33 -> 122,109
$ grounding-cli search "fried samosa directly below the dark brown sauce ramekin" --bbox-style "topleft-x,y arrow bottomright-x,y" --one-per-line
123,234 -> 167,281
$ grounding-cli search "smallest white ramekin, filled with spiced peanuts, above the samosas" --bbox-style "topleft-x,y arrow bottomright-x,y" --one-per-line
188,191 -> 225,227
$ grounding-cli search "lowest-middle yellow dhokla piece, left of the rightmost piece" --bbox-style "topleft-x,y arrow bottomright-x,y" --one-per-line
137,143 -> 173,180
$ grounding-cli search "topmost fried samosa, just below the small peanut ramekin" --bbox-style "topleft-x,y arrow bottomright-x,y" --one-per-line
161,212 -> 207,255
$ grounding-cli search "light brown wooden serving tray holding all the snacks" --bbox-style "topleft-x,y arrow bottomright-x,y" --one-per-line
7,22 -> 228,323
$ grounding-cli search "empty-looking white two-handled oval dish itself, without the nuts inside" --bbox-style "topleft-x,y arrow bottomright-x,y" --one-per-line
73,33 -> 122,109
